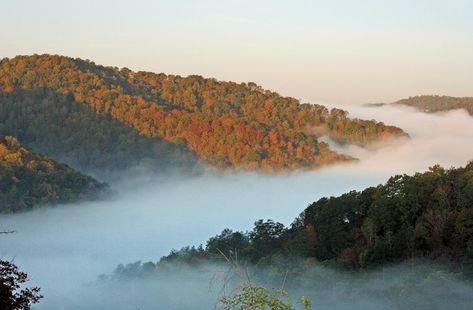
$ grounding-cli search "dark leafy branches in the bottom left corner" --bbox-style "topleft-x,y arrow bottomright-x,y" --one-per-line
0,260 -> 43,310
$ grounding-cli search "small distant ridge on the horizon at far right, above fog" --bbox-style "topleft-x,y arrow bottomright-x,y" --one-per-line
394,96 -> 473,115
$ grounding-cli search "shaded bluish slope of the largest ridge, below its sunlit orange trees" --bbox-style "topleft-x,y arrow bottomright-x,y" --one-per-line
0,88 -> 197,179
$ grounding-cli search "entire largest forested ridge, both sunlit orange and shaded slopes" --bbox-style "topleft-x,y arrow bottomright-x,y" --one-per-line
0,55 -> 406,171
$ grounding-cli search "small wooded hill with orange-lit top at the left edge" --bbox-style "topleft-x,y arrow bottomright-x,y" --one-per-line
0,136 -> 107,212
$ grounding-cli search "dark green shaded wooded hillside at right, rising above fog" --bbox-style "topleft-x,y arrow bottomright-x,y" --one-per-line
160,162 -> 473,270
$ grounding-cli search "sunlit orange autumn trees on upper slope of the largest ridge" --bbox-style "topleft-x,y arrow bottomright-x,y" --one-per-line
0,55 -> 406,171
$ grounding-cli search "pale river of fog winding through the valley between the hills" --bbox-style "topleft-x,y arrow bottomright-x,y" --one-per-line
0,106 -> 473,309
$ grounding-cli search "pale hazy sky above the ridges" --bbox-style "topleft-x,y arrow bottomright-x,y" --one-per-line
0,0 -> 473,103
